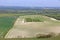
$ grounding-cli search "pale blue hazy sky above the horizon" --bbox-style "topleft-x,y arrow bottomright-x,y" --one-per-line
0,0 -> 60,7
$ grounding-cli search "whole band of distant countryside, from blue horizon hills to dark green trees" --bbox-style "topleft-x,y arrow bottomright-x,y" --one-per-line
0,6 -> 60,20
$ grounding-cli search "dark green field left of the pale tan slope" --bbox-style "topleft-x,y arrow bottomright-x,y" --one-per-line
0,16 -> 17,38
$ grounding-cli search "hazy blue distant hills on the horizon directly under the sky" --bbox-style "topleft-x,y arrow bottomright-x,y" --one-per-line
0,6 -> 60,10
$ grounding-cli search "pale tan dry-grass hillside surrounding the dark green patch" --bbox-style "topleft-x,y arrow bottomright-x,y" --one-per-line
5,15 -> 60,38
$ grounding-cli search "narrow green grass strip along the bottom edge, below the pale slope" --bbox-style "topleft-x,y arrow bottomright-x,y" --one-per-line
0,35 -> 60,40
